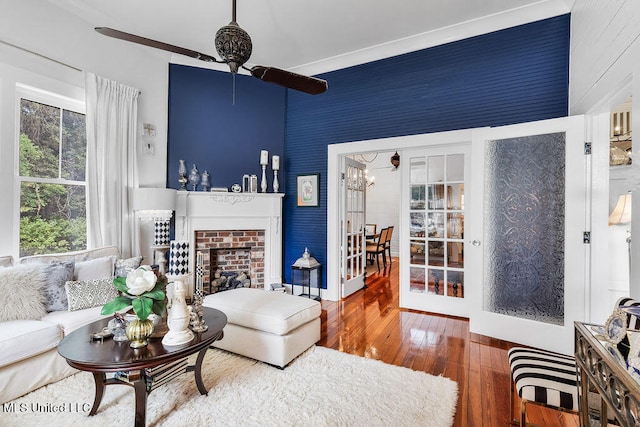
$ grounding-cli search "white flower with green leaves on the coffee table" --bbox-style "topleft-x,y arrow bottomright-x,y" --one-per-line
101,265 -> 167,320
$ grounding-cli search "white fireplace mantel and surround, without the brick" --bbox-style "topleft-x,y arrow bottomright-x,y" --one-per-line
175,191 -> 284,289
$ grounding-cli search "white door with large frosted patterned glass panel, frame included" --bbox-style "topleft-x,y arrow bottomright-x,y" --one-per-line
465,117 -> 589,354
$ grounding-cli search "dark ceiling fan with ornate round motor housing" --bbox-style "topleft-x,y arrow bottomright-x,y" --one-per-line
95,0 -> 327,95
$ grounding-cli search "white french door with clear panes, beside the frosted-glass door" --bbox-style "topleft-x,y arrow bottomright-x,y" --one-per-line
400,143 -> 471,317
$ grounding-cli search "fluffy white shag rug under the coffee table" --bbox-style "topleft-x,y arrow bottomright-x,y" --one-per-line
0,347 -> 458,427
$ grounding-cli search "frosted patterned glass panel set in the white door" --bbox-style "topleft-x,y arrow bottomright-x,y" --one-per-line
483,133 -> 565,325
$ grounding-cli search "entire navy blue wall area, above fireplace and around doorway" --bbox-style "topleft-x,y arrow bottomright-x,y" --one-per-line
167,15 -> 570,287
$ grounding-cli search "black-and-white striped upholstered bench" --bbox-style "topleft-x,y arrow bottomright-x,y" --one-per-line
508,347 -> 578,426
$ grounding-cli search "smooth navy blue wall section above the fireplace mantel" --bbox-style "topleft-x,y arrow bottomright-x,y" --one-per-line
167,64 -> 287,192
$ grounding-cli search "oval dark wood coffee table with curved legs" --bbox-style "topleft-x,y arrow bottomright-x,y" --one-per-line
58,307 -> 227,427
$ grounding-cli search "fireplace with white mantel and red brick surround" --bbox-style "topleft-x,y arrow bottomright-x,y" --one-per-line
175,191 -> 283,291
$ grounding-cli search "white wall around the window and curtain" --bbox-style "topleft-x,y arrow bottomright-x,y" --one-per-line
0,0 -> 169,257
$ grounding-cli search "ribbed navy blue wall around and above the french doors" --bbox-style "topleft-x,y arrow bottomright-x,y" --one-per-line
283,15 -> 570,288
